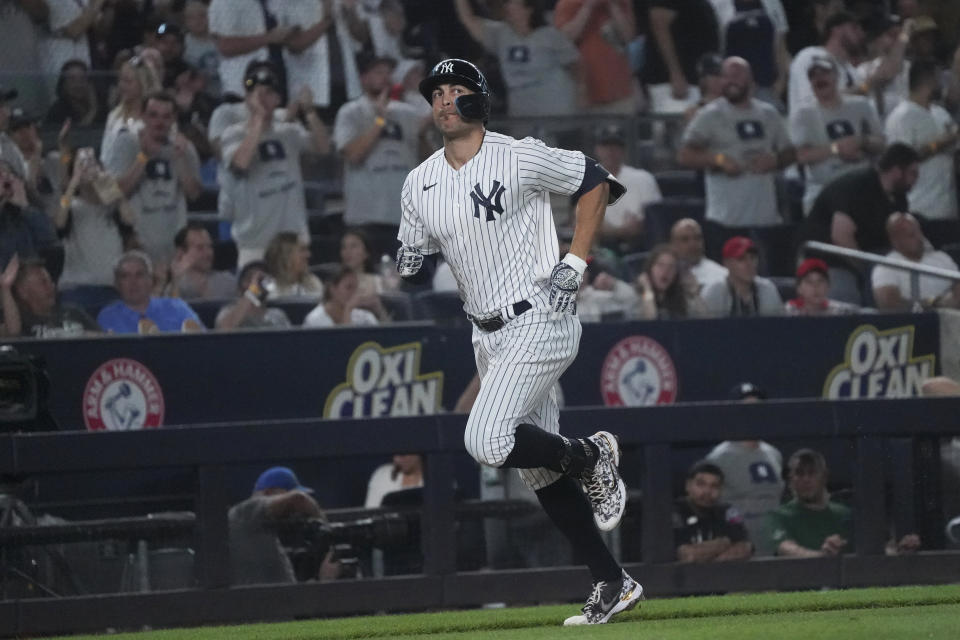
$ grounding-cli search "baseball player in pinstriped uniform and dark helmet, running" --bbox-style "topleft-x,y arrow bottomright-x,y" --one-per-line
397,59 -> 643,625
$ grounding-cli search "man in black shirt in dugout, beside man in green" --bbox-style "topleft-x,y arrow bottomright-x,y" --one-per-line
673,460 -> 753,562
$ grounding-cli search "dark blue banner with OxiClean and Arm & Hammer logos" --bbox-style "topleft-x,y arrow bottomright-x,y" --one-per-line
17,314 -> 939,430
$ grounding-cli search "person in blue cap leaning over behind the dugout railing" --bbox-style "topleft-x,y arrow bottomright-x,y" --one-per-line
227,467 -> 340,584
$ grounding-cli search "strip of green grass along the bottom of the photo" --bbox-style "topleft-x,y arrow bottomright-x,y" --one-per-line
58,585 -> 960,640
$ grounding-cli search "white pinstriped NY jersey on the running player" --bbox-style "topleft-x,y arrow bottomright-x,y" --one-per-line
398,131 -> 584,317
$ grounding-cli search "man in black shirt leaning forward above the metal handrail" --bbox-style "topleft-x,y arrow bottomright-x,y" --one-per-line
802,143 -> 919,304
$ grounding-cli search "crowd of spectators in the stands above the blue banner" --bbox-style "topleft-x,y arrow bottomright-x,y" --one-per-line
0,0 -> 960,335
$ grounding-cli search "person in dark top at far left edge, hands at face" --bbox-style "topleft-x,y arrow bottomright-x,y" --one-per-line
0,160 -> 57,269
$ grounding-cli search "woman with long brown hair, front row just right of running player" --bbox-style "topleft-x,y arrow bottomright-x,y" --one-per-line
634,244 -> 704,320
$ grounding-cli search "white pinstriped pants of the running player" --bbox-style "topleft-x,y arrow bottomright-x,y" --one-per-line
463,308 -> 583,491
